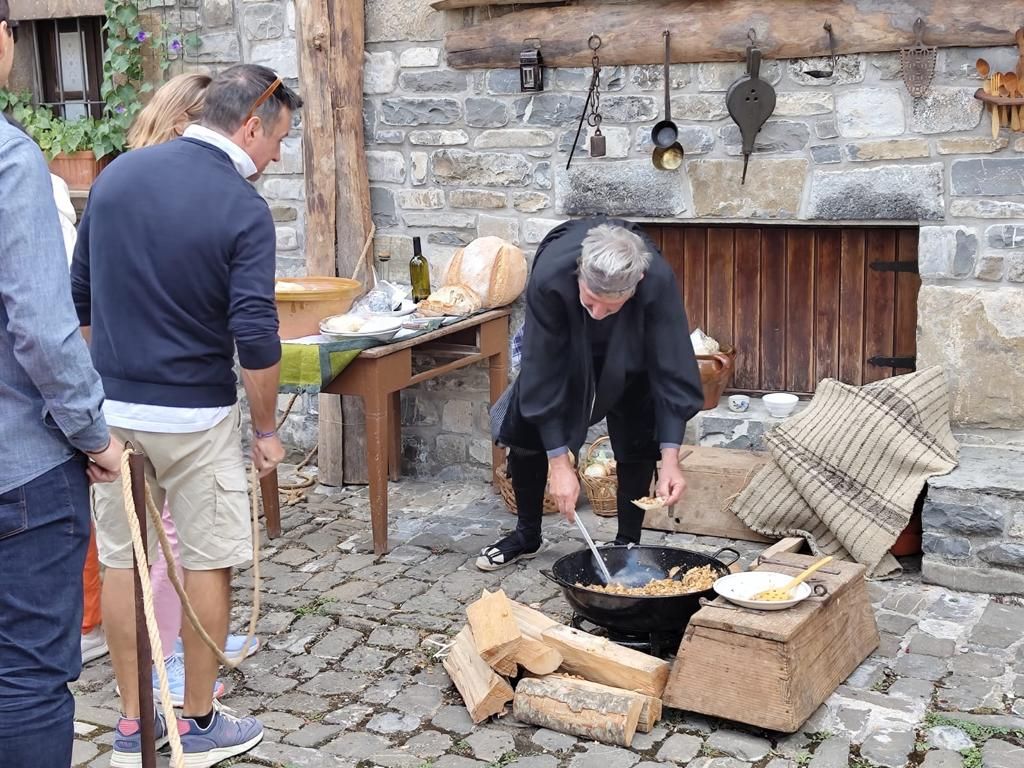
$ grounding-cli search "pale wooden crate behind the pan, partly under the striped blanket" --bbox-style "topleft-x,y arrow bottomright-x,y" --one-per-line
643,446 -> 772,542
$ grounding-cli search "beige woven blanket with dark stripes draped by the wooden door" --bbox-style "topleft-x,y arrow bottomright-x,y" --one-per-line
731,368 -> 958,578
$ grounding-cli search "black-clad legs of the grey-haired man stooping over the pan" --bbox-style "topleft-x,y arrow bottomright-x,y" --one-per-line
508,375 -> 658,549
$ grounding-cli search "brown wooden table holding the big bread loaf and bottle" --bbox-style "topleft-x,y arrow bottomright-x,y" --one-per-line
261,309 -> 510,555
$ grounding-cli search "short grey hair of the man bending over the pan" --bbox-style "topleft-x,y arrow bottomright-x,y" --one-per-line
577,224 -> 651,296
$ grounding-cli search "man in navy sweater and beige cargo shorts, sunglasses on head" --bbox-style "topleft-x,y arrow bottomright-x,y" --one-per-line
72,65 -> 302,766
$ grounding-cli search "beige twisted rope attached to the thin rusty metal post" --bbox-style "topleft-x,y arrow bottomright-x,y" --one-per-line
121,450 -> 266,768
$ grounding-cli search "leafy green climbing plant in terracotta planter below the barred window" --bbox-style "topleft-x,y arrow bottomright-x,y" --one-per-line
0,0 -> 186,189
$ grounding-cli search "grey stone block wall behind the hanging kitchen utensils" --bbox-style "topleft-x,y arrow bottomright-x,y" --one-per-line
192,0 -> 1024,473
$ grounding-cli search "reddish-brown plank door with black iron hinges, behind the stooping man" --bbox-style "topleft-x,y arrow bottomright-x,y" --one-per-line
645,225 -> 921,394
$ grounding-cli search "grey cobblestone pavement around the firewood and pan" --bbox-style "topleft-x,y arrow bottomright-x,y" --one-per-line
74,468 -> 1024,768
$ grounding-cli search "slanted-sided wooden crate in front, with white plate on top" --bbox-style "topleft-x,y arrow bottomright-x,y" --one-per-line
663,553 -> 879,733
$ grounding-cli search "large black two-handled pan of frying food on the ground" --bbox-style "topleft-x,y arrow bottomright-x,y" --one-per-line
541,545 -> 739,635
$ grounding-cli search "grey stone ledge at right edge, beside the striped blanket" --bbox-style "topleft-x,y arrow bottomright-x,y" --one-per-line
922,445 -> 1024,594
